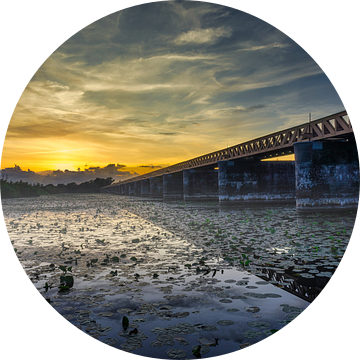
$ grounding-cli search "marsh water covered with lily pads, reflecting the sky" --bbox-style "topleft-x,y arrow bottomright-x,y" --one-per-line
2,194 -> 357,359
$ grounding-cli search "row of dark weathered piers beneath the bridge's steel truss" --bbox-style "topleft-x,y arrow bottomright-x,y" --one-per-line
101,136 -> 360,208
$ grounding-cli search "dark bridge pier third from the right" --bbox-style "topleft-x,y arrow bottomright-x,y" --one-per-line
183,165 -> 219,201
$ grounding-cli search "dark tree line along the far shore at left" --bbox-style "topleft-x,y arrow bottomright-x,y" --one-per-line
0,177 -> 114,199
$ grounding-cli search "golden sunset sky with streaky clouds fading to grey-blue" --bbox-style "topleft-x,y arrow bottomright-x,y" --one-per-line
0,0 -> 345,186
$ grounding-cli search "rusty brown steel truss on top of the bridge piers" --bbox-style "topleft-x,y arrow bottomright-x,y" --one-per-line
102,110 -> 354,187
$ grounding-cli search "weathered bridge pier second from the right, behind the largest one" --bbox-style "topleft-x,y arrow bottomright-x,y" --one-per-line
218,159 -> 295,202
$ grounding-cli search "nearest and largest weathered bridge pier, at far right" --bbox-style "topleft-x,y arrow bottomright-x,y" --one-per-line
294,138 -> 360,208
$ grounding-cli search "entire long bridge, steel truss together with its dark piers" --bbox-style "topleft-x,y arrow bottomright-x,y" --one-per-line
101,111 -> 360,208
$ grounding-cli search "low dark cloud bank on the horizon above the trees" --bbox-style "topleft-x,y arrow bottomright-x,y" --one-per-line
0,164 -> 139,185
